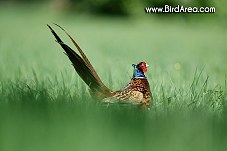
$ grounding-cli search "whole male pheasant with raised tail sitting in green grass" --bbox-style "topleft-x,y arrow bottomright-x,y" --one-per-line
47,24 -> 153,106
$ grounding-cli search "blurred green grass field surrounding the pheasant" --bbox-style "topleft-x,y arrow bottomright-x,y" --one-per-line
0,6 -> 227,151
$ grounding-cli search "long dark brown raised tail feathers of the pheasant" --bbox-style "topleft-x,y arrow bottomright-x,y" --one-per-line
47,25 -> 111,97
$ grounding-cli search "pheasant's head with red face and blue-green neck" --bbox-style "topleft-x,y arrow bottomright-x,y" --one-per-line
132,62 -> 149,78
